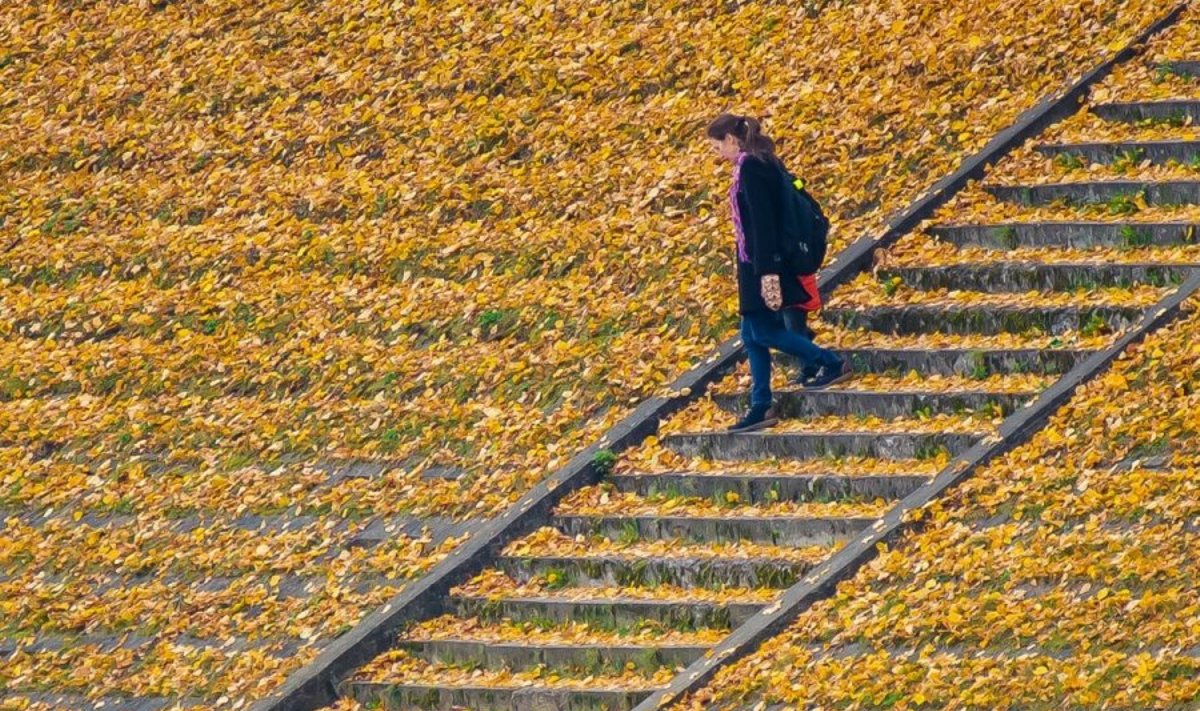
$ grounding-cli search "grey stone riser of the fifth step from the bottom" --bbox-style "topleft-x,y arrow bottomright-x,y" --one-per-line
554,516 -> 874,545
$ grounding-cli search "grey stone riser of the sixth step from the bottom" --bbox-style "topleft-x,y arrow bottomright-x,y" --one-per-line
608,472 -> 929,503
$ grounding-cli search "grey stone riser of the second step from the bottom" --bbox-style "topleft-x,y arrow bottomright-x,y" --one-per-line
396,639 -> 708,675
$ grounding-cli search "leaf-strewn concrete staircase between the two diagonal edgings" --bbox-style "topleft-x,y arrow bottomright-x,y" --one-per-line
341,61 -> 1200,710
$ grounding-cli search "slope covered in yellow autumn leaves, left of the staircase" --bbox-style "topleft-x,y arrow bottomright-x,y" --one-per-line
0,0 -> 1185,707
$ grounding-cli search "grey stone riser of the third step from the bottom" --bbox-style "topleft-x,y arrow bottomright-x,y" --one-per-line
449,595 -> 766,629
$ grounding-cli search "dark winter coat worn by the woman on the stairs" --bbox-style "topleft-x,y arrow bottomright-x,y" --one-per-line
734,155 -> 811,313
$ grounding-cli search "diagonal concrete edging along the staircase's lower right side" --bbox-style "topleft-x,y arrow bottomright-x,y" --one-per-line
635,269 -> 1200,711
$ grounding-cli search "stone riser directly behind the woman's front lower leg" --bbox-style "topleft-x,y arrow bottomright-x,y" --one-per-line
713,388 -> 1036,418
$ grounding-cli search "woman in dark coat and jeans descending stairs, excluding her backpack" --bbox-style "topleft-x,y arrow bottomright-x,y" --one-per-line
708,114 -> 850,432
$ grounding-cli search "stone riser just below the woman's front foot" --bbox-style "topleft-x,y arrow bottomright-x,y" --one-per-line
664,432 -> 976,461
